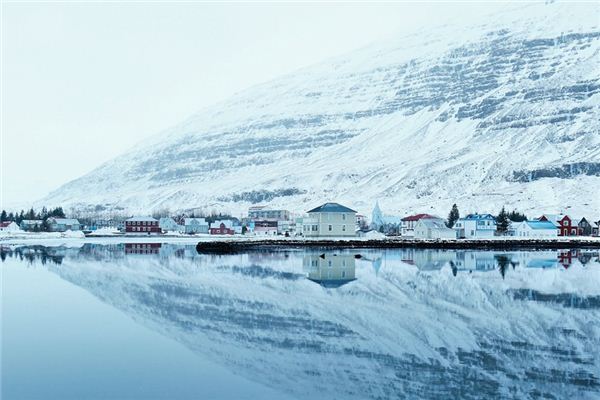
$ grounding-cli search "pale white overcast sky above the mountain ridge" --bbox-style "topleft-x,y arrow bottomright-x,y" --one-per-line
1,2 -> 506,208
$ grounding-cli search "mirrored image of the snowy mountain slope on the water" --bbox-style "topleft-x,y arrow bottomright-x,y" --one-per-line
32,245 -> 600,399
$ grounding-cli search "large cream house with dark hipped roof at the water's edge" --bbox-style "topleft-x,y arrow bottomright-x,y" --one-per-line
302,203 -> 356,238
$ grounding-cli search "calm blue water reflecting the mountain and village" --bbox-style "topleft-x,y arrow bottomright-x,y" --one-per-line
1,243 -> 600,399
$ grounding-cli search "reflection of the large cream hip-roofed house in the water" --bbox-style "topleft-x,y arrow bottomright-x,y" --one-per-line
302,254 -> 356,288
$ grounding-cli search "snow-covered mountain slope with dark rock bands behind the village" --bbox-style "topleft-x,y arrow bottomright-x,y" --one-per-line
40,3 -> 600,214
